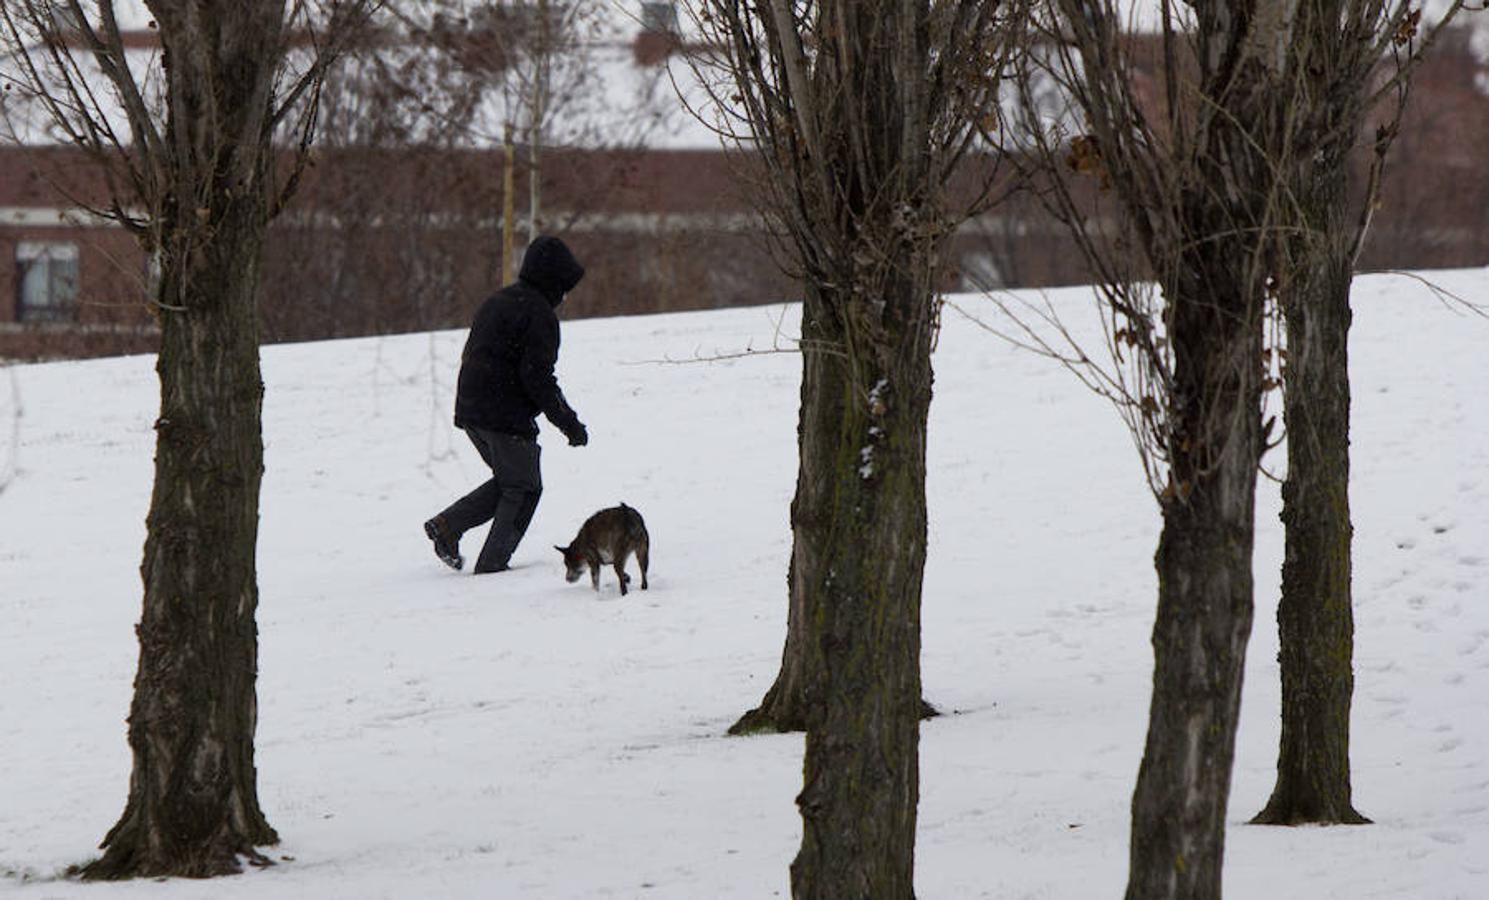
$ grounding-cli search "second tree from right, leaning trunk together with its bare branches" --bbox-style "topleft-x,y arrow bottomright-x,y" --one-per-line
1024,0 -> 1286,900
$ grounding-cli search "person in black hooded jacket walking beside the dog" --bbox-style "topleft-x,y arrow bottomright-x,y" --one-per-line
424,235 -> 590,575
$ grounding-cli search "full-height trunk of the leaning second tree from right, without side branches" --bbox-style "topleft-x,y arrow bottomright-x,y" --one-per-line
1126,26 -> 1278,900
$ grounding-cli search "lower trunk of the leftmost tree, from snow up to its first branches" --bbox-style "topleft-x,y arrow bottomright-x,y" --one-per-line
85,210 -> 278,878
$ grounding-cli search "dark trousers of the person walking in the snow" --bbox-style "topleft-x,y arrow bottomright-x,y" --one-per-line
441,428 -> 543,574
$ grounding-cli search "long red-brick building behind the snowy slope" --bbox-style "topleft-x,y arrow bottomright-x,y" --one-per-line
0,12 -> 1489,358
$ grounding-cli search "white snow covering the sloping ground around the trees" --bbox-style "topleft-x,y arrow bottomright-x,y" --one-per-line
0,270 -> 1489,900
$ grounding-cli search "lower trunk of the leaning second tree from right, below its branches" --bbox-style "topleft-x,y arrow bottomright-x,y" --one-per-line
1127,262 -> 1261,900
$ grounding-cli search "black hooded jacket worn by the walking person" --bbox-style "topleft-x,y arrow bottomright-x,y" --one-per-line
456,235 -> 584,438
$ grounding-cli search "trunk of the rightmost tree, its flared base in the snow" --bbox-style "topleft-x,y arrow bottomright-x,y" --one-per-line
1252,152 -> 1368,825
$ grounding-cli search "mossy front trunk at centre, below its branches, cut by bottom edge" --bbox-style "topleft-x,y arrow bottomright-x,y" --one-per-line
791,281 -> 931,900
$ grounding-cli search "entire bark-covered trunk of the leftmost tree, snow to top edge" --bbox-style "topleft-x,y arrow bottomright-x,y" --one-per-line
83,0 -> 284,879
